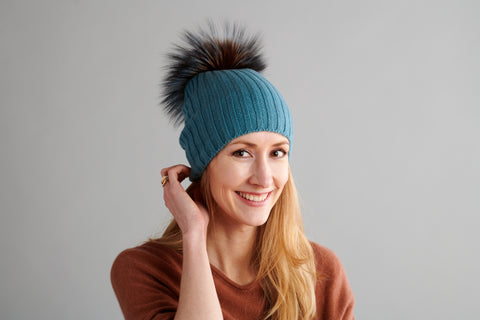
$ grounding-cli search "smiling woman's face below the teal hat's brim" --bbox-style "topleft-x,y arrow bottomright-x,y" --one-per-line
208,131 -> 289,226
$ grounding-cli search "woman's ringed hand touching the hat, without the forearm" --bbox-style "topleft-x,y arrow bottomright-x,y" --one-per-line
161,165 -> 208,235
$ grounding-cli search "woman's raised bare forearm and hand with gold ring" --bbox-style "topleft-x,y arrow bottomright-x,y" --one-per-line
162,165 -> 223,320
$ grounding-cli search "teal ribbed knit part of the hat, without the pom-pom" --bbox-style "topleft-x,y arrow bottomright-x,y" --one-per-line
180,69 -> 293,181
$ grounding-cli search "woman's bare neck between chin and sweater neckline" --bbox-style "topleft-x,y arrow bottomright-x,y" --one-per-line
207,225 -> 258,285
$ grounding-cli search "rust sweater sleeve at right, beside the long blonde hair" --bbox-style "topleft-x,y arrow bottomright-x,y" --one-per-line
312,243 -> 355,320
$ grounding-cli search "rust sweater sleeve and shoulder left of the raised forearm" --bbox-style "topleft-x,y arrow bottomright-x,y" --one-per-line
111,243 -> 181,320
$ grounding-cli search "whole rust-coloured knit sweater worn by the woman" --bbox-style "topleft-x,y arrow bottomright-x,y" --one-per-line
111,242 -> 354,320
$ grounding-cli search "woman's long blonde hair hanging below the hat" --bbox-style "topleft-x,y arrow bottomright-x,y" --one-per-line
153,168 -> 317,320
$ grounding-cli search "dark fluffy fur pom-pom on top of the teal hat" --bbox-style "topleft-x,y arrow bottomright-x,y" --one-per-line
162,23 -> 266,125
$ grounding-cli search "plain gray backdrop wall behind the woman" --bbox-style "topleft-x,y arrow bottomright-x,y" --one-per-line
0,0 -> 480,319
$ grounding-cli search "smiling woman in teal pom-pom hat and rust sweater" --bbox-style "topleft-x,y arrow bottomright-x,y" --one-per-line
111,23 -> 354,320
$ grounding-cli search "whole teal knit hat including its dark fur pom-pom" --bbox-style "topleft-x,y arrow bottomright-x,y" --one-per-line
163,24 -> 293,181
